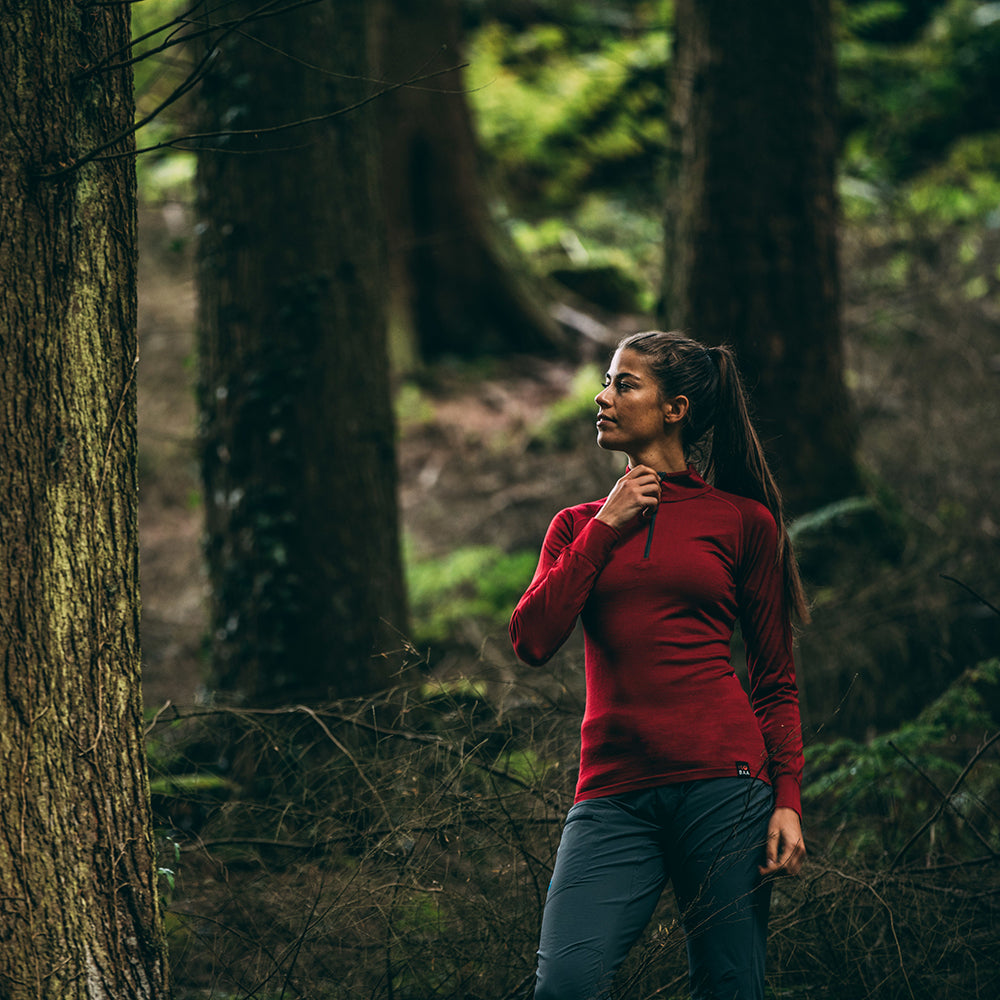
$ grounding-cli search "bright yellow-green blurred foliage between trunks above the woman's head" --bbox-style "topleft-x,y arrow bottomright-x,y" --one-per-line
468,4 -> 669,302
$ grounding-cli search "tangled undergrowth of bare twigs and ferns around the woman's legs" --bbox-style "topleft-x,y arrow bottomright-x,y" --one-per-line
149,661 -> 1000,1000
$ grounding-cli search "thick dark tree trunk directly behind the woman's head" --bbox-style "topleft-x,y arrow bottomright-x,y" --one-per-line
663,0 -> 860,512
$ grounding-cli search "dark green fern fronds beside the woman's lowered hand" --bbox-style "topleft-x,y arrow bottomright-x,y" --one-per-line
803,659 -> 1000,863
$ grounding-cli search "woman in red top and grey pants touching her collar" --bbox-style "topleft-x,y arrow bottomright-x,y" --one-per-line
510,332 -> 808,1000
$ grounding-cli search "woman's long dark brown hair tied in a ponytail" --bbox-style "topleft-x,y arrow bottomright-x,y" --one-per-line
618,330 -> 809,622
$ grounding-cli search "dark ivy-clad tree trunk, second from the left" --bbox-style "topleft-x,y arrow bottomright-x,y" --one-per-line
199,0 -> 406,705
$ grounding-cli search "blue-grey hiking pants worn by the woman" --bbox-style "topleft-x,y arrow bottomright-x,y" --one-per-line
535,778 -> 773,1000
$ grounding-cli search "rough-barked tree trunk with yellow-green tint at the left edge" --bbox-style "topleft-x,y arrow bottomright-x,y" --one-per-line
0,0 -> 167,1000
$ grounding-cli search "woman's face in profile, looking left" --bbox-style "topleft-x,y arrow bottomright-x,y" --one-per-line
594,348 -> 669,455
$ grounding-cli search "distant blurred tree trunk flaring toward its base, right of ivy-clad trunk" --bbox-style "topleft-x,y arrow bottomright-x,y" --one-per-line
375,0 -> 567,364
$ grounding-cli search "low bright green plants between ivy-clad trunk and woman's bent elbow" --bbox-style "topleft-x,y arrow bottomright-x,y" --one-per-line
406,546 -> 537,643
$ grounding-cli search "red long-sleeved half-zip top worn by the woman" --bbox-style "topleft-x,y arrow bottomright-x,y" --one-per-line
510,469 -> 802,812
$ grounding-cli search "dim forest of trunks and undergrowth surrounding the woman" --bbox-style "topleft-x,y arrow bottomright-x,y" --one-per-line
0,0 -> 1000,1000
